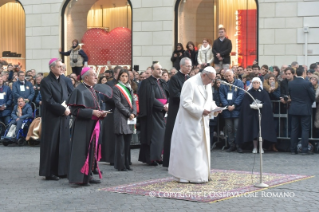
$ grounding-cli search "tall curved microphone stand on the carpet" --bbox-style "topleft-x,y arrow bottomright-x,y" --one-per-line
221,80 -> 268,188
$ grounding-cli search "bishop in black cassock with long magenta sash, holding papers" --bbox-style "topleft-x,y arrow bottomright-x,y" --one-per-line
67,67 -> 111,185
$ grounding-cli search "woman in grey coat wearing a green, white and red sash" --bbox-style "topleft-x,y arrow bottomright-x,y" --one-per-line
113,69 -> 136,171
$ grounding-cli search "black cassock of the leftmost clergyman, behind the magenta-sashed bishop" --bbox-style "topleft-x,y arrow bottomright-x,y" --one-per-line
39,72 -> 70,177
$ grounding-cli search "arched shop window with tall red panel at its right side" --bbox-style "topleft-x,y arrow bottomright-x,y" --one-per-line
175,0 -> 258,67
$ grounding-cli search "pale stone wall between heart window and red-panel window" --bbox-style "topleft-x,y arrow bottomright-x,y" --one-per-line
131,0 -> 176,70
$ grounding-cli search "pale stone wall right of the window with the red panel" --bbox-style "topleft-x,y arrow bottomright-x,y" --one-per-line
259,0 -> 319,67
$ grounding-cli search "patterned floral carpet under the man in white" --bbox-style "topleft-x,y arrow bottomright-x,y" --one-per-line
100,169 -> 313,203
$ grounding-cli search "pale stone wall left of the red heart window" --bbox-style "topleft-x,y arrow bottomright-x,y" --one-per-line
20,0 -> 64,72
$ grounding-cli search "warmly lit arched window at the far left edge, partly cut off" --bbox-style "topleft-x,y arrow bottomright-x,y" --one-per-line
0,0 -> 26,70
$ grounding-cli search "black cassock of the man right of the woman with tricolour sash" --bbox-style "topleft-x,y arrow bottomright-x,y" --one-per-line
138,76 -> 169,164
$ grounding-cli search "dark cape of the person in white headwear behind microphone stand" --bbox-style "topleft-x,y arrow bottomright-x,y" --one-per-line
236,88 -> 277,144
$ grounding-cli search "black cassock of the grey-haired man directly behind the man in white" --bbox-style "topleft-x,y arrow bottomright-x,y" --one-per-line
163,71 -> 189,167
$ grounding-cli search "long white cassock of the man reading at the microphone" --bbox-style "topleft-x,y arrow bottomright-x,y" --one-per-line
168,74 -> 217,182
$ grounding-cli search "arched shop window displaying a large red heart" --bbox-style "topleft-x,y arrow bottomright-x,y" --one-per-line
61,0 -> 132,73
